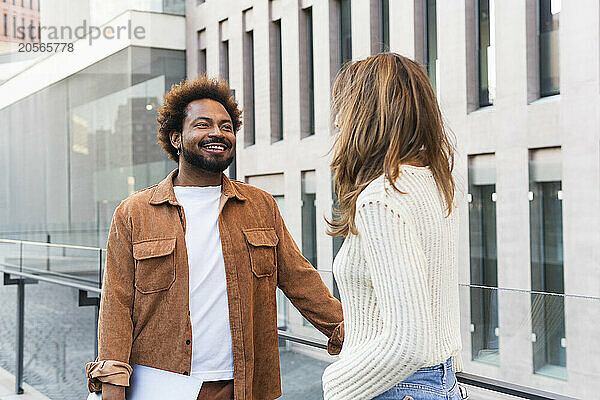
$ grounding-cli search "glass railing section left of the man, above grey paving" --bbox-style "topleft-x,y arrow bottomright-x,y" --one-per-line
0,239 -> 105,400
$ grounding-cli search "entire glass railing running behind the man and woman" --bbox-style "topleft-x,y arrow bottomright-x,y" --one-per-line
0,239 -> 600,400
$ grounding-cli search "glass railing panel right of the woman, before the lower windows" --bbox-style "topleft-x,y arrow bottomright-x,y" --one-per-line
459,285 -> 600,399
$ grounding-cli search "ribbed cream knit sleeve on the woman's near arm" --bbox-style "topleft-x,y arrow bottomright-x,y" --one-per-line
323,199 -> 432,400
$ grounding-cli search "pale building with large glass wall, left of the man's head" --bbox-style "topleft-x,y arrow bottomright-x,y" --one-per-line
0,0 -> 185,247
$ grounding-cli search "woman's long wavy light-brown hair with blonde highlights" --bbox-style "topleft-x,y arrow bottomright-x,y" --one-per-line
326,53 -> 454,237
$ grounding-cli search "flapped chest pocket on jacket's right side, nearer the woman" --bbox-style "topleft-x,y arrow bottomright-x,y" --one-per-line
243,228 -> 279,278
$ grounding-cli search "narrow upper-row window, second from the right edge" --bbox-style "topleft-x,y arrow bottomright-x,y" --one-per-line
477,0 -> 496,107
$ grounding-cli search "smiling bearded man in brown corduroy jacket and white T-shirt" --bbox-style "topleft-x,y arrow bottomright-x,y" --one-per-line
86,77 -> 343,400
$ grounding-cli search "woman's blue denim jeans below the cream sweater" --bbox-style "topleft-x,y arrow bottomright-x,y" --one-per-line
373,359 -> 462,400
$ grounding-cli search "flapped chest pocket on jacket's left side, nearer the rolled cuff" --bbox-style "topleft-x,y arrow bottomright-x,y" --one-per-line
133,238 -> 175,294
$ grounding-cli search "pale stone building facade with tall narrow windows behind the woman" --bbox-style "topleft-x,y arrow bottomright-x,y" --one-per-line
186,0 -> 600,398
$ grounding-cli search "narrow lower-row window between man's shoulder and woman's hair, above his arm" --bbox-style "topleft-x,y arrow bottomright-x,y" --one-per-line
302,171 -> 317,267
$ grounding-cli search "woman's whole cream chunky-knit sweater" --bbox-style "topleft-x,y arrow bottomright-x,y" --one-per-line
323,166 -> 462,400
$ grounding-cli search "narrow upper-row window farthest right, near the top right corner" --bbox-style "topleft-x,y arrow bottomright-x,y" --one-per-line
539,0 -> 561,97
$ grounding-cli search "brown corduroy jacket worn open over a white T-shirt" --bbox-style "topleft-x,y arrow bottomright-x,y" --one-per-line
86,170 -> 343,400
